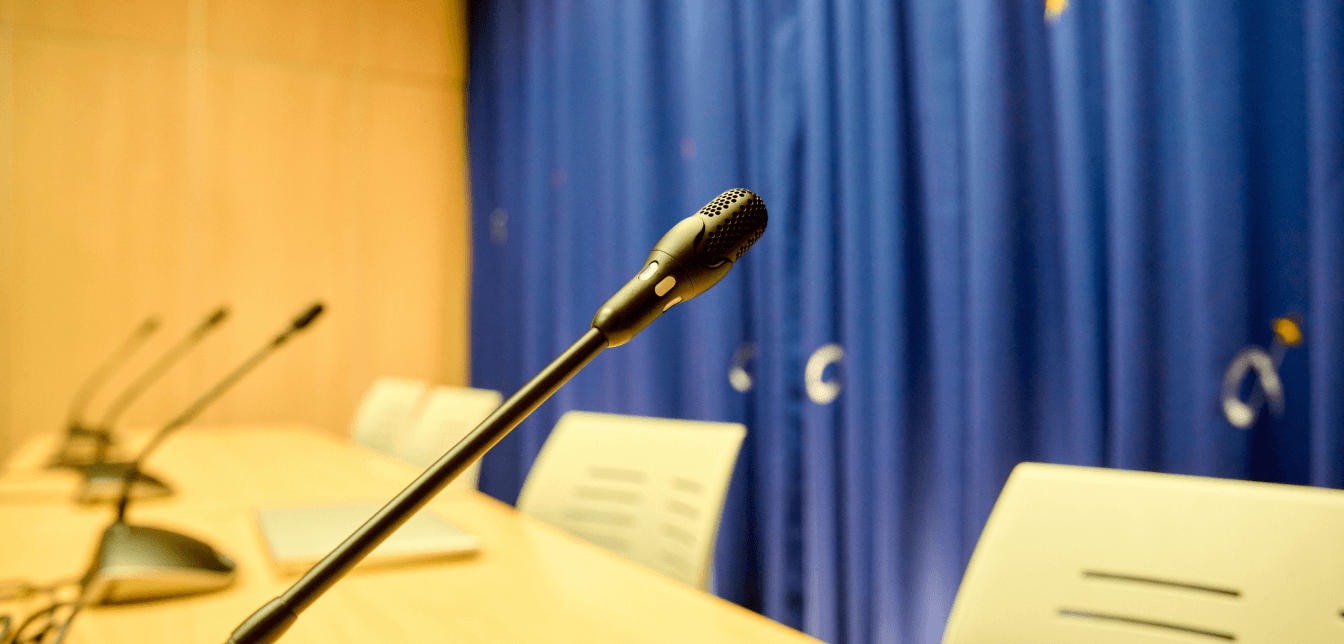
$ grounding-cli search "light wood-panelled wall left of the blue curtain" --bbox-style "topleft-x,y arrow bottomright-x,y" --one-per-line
0,0 -> 469,456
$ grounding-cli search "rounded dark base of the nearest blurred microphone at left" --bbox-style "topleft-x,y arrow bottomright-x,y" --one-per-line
81,522 -> 237,604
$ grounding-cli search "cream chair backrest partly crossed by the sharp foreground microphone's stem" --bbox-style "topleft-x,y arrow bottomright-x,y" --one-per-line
396,387 -> 504,489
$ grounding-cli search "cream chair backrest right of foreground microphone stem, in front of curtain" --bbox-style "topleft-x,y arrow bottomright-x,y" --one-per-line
517,411 -> 746,588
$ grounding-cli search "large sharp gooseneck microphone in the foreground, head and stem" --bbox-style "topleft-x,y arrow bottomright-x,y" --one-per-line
228,190 -> 766,644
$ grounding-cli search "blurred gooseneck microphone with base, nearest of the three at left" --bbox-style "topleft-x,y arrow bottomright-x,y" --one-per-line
81,304 -> 323,604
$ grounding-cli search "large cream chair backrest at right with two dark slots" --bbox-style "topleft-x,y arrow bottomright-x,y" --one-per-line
942,464 -> 1344,644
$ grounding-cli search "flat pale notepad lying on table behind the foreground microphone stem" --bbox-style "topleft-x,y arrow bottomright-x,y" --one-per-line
257,503 -> 480,573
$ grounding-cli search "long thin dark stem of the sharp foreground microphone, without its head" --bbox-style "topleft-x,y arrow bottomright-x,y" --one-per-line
228,328 -> 607,644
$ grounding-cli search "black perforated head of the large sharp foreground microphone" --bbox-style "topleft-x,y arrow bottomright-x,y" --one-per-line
593,188 -> 769,347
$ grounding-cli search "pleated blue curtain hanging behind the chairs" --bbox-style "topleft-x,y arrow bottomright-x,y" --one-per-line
468,0 -> 1344,644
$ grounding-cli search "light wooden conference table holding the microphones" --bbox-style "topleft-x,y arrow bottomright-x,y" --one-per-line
0,425 -> 817,644
